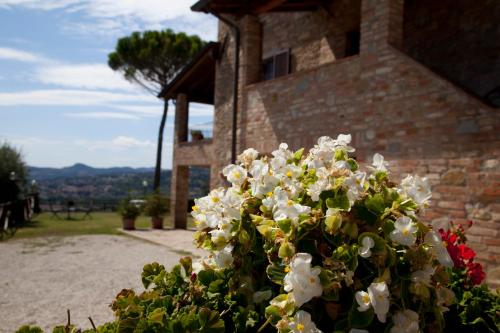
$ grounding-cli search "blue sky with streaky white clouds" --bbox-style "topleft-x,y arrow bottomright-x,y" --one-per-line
0,0 -> 217,168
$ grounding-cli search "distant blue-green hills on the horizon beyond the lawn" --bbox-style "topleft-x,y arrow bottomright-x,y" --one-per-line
28,163 -> 210,204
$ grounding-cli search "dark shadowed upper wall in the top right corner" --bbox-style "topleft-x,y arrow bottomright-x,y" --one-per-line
404,0 -> 500,102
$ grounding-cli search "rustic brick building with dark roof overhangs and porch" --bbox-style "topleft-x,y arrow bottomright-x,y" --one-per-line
163,0 -> 500,279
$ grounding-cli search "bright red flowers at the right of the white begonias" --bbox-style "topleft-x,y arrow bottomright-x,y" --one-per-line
439,221 -> 486,286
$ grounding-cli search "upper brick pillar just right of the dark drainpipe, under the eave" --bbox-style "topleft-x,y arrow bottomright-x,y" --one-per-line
240,15 -> 262,86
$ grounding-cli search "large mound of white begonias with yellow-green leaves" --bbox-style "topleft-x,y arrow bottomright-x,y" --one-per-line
188,135 -> 472,333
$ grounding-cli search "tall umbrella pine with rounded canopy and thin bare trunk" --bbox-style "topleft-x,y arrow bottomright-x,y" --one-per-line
108,29 -> 205,191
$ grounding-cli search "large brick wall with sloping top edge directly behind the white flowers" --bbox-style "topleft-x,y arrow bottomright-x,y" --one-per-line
240,45 -> 500,282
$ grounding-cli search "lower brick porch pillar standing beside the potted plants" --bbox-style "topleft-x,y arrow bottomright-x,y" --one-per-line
170,161 -> 189,229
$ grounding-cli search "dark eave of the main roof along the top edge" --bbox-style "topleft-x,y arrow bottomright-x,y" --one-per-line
191,0 -> 331,16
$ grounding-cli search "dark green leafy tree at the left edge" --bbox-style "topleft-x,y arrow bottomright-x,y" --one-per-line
0,143 -> 28,203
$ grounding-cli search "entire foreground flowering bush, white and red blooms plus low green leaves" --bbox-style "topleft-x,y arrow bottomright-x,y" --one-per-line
15,135 -> 499,333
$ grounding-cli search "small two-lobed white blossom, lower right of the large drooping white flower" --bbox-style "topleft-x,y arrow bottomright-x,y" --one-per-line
355,282 -> 390,323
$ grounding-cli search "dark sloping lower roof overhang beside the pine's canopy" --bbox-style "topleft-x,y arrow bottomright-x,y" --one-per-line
158,42 -> 219,104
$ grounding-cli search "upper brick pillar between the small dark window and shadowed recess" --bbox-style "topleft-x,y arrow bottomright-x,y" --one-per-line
360,0 -> 404,54
